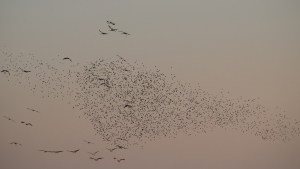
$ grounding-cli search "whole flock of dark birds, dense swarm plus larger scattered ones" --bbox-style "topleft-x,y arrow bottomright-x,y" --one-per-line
1,21 -> 300,162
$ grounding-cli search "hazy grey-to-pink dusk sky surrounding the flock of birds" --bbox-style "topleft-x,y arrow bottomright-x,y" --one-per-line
0,0 -> 300,169
